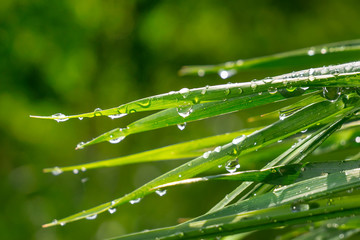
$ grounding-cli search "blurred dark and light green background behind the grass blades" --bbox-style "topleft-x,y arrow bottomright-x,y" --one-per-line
0,0 -> 360,240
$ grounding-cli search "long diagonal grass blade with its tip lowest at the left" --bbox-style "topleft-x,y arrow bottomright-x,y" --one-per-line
44,96 -> 354,227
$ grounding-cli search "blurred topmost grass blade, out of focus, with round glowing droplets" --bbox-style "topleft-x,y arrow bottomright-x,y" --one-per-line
179,39 -> 360,78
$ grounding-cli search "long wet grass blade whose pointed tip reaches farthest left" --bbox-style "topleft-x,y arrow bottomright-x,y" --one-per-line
30,62 -> 360,121
